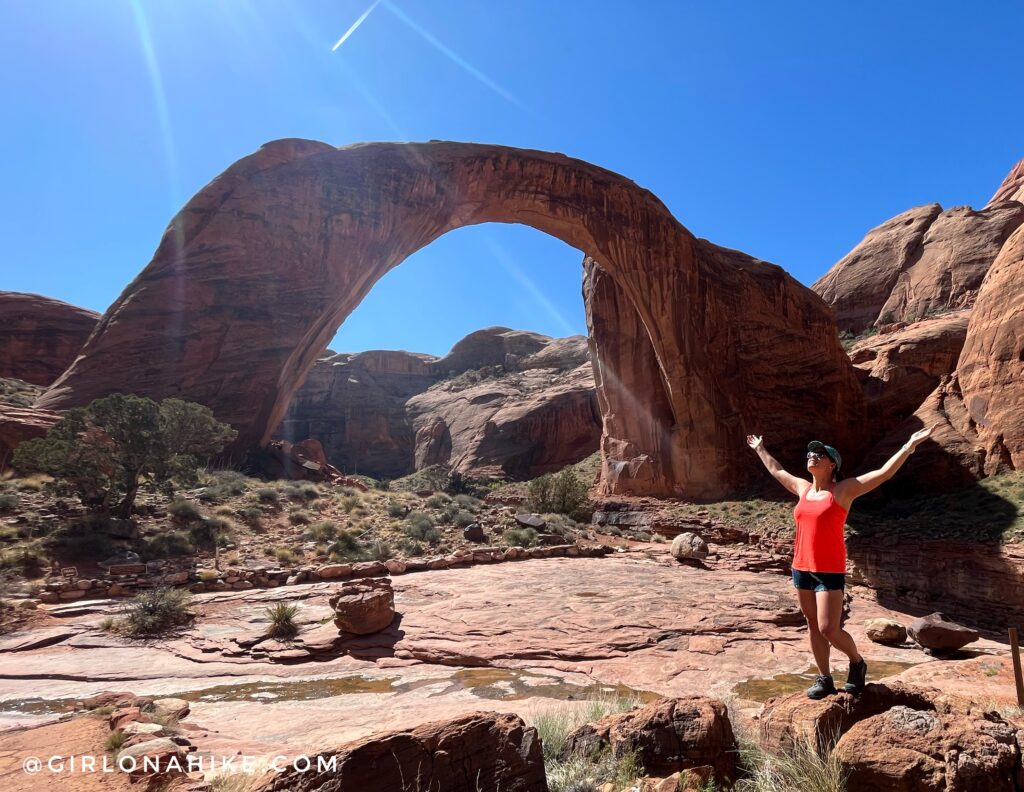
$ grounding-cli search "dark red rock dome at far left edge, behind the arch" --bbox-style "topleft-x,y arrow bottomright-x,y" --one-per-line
0,291 -> 99,385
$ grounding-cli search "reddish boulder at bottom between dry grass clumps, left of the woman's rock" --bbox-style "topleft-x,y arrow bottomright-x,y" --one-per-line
562,696 -> 737,784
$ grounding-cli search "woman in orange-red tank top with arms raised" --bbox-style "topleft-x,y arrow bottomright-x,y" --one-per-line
746,426 -> 934,699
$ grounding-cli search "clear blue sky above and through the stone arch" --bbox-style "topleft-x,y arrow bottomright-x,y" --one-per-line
0,0 -> 1024,355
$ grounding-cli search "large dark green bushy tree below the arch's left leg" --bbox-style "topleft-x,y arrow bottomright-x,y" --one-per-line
13,393 -> 238,517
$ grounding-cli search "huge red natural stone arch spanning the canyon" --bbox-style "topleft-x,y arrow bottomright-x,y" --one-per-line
38,139 -> 863,497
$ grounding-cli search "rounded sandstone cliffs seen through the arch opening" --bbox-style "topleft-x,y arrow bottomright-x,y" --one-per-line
279,328 -> 601,478
